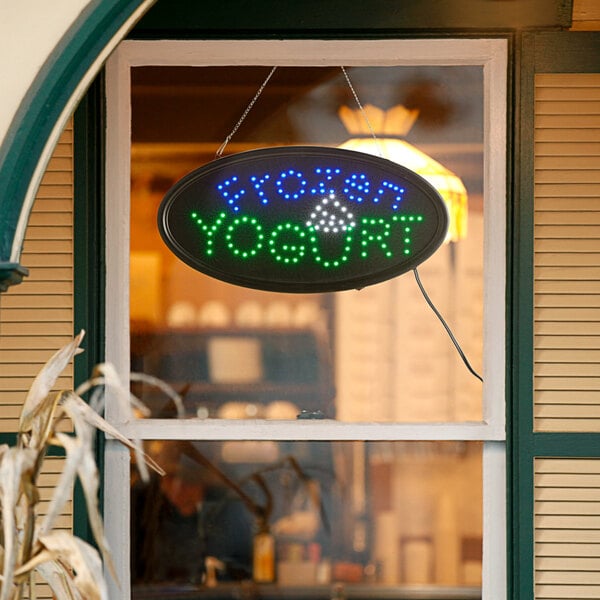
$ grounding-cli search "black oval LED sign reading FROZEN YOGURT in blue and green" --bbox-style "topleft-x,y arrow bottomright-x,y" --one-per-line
158,146 -> 448,292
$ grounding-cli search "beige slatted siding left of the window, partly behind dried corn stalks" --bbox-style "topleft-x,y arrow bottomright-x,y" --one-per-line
0,124 -> 74,600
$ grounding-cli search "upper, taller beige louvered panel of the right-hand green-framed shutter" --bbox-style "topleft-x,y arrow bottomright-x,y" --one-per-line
534,74 -> 600,432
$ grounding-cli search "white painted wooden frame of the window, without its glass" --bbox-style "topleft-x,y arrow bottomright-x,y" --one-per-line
104,39 -> 507,600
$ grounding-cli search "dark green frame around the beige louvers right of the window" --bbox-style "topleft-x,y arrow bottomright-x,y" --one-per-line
509,32 -> 600,600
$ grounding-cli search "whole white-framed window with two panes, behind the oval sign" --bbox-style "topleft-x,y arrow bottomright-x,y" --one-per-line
106,40 -> 506,600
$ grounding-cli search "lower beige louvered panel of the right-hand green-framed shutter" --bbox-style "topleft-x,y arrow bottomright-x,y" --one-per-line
534,458 -> 600,600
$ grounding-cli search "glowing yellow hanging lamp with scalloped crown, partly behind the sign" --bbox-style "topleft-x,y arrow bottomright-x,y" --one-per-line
338,104 -> 468,242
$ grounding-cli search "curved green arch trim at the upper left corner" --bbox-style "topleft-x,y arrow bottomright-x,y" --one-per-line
0,0 -> 152,261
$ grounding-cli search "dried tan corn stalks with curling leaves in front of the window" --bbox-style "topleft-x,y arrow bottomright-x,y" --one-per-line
0,331 -> 171,600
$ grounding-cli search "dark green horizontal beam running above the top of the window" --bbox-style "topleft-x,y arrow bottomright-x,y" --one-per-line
131,0 -> 572,39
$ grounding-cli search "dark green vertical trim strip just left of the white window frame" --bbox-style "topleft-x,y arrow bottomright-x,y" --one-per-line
73,74 -> 105,543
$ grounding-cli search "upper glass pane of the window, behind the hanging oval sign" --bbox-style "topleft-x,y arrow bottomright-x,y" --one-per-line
130,66 -> 483,422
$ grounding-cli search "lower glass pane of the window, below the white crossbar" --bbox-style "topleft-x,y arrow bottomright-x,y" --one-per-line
131,441 -> 482,600
